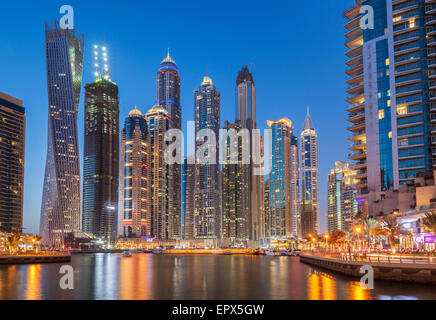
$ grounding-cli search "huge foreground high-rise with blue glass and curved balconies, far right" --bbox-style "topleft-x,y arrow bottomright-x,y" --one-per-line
344,0 -> 436,215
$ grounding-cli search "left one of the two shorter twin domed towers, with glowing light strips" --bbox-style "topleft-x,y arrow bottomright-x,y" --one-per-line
119,107 -> 148,238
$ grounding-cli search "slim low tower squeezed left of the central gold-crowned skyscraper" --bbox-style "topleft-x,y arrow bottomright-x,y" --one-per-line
183,156 -> 195,240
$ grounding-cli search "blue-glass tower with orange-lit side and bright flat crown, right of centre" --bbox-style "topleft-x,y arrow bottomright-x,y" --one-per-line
265,118 -> 299,238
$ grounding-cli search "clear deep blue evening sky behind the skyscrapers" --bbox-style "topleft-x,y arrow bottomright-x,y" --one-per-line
0,0 -> 353,233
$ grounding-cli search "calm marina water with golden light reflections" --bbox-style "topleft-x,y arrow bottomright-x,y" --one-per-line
0,254 -> 436,300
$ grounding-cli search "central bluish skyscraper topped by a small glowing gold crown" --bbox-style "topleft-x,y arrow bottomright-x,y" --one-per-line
194,77 -> 221,239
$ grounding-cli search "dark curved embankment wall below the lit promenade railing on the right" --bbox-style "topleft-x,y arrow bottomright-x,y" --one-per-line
300,254 -> 436,284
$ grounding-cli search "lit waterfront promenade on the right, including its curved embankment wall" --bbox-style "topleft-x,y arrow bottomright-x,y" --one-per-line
300,251 -> 436,284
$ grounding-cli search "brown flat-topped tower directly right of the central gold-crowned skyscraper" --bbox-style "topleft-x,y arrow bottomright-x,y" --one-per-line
222,121 -> 250,245
